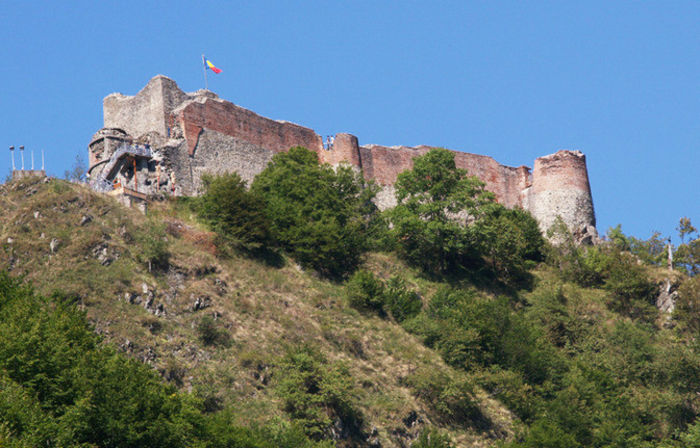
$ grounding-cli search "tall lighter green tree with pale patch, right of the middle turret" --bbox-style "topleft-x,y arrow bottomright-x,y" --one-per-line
390,148 -> 493,274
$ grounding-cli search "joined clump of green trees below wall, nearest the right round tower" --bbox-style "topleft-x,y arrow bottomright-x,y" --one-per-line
389,148 -> 544,280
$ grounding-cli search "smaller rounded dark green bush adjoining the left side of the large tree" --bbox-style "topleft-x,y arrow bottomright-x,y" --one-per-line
195,173 -> 273,253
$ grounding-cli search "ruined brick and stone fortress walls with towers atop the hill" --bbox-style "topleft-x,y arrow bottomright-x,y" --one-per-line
89,75 -> 597,241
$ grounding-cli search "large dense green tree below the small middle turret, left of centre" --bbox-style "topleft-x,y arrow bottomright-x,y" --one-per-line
251,147 -> 377,278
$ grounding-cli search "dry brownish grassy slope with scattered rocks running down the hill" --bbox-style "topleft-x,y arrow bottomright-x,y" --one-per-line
0,180 -> 517,446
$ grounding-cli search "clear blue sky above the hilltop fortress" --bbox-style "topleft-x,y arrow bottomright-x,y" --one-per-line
0,0 -> 700,242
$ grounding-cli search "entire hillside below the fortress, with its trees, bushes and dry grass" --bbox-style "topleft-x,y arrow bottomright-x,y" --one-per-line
0,148 -> 700,448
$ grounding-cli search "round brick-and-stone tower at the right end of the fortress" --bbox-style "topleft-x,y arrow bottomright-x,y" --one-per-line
529,150 -> 598,243
